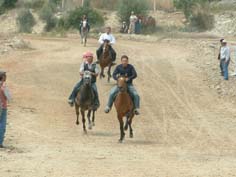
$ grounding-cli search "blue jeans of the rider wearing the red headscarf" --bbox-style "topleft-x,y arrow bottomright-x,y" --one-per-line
69,80 -> 100,106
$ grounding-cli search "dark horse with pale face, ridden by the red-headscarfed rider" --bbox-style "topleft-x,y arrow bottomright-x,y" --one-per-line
75,71 -> 96,133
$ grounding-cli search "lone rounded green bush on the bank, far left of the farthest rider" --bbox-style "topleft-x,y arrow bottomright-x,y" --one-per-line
17,9 -> 35,33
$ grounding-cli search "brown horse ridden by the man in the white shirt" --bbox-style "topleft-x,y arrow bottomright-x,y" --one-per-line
99,40 -> 113,82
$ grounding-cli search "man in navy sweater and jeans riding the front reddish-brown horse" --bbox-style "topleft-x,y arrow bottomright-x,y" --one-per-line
105,55 -> 140,115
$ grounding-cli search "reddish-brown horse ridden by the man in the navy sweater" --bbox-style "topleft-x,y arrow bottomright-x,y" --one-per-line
114,76 -> 134,143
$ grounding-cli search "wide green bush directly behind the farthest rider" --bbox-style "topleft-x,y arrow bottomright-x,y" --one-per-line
65,7 -> 104,29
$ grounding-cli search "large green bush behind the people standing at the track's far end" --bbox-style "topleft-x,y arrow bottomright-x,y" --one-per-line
118,0 -> 148,22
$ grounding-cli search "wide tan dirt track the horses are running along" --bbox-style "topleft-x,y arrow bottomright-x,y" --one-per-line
0,37 -> 236,177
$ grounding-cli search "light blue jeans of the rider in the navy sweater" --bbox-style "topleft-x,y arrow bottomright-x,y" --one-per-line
107,84 -> 140,109
